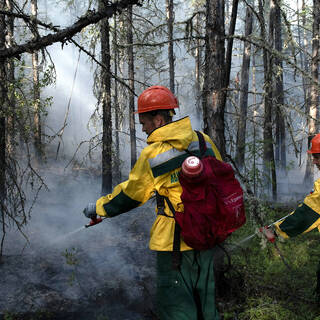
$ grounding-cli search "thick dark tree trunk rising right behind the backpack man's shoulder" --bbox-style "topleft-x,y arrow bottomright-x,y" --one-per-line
203,0 -> 226,159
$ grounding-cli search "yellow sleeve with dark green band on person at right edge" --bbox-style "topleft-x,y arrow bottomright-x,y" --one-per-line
275,179 -> 320,238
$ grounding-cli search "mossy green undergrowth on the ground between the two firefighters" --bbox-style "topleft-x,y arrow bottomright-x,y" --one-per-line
217,205 -> 320,320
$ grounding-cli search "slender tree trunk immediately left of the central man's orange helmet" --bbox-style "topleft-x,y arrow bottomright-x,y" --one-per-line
127,5 -> 137,168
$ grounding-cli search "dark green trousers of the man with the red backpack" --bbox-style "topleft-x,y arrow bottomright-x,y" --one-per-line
157,250 -> 220,320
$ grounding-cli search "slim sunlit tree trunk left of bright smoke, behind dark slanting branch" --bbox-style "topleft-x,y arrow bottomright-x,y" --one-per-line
31,0 -> 43,161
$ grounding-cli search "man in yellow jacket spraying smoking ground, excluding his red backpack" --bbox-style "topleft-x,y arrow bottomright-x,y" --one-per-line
84,86 -> 221,320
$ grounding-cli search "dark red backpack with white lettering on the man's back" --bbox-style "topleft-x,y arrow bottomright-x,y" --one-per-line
161,131 -> 246,255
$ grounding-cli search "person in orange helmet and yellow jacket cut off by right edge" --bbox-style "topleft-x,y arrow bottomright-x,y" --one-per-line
266,133 -> 320,297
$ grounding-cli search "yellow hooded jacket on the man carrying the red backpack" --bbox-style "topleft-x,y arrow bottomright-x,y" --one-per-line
96,117 -> 221,251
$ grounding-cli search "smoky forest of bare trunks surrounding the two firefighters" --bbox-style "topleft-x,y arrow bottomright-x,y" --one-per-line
0,0 -> 320,320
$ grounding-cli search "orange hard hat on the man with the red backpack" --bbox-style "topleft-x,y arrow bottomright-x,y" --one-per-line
135,86 -> 179,113
